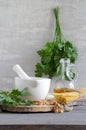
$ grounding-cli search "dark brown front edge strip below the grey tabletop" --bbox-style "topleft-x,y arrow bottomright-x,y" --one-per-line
0,125 -> 86,130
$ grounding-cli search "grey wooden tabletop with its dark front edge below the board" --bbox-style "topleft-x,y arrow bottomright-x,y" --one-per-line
0,103 -> 86,130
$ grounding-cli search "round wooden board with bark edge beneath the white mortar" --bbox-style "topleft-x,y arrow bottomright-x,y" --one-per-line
1,105 -> 54,112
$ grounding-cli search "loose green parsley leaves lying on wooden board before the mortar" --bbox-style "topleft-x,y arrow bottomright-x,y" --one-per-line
0,88 -> 33,108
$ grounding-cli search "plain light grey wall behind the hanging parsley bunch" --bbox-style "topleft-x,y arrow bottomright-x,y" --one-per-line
0,0 -> 86,90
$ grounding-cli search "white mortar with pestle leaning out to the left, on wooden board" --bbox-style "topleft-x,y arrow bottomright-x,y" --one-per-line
13,64 -> 51,100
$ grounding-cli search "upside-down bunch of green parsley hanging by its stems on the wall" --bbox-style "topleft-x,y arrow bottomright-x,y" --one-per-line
35,7 -> 78,79
